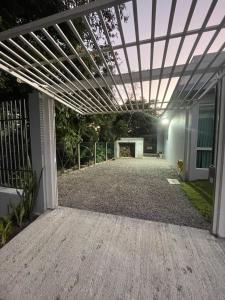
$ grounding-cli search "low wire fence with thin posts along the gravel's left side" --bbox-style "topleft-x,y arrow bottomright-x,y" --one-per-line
77,142 -> 114,169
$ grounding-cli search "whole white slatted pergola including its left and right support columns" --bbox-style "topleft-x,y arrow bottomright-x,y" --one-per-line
0,0 -> 225,237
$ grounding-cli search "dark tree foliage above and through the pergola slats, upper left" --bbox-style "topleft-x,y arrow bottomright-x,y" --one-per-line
0,0 -> 127,97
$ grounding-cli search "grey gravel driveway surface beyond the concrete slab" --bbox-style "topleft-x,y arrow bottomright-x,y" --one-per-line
58,158 -> 209,229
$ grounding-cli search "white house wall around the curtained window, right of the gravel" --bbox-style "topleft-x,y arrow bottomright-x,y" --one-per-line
163,93 -> 215,181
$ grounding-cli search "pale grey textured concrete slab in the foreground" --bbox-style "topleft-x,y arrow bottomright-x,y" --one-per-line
0,208 -> 225,300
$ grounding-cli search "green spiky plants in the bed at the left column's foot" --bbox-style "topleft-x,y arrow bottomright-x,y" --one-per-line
0,171 -> 41,248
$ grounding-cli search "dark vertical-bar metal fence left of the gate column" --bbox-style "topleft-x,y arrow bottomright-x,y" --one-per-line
0,99 -> 31,188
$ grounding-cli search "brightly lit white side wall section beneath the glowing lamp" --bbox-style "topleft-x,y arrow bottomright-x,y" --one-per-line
161,111 -> 186,167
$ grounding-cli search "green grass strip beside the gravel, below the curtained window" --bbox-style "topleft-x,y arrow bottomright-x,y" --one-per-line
180,180 -> 213,222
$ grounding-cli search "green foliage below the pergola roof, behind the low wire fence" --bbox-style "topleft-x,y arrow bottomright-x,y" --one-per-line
56,105 -> 156,169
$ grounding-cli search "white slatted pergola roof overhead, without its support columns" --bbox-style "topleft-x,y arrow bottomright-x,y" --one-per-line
0,0 -> 225,115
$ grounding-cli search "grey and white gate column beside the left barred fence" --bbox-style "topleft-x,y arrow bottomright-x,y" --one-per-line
29,92 -> 58,214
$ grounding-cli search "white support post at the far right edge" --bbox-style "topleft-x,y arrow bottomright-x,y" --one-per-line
212,78 -> 225,238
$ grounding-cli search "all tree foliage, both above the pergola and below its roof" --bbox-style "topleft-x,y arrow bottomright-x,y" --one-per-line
0,0 -> 157,168
